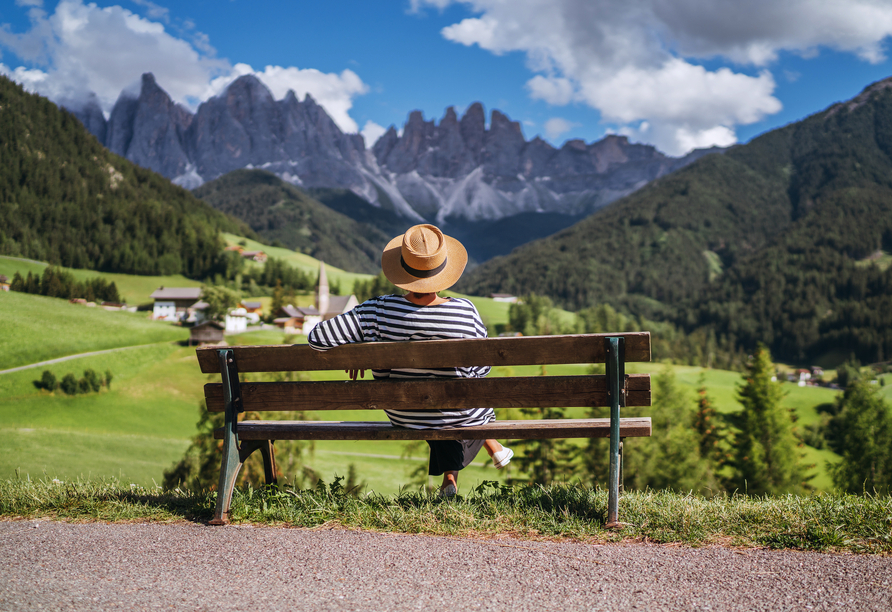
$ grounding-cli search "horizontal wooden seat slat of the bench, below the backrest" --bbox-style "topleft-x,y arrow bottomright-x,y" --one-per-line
214,417 -> 651,440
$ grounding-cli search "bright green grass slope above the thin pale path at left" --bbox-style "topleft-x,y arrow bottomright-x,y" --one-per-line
0,291 -> 189,370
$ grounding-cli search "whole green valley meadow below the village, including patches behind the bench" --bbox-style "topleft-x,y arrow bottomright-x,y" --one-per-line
0,270 -> 844,493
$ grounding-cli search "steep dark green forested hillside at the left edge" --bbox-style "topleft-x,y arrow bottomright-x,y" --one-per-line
0,77 -> 254,278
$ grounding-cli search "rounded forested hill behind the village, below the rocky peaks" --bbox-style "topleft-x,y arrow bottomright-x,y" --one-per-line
193,170 -> 390,274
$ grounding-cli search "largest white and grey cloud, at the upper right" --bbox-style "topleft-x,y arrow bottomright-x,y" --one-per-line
422,0 -> 892,154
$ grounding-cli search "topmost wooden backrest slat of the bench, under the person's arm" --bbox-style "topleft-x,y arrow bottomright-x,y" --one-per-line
196,332 -> 650,374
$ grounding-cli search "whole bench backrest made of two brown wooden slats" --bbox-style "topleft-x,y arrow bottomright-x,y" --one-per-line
197,332 -> 651,412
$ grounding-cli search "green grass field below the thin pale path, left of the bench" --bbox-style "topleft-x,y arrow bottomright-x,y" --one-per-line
0,343 -> 204,485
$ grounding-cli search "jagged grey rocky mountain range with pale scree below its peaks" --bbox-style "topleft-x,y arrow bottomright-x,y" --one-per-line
64,73 -> 709,233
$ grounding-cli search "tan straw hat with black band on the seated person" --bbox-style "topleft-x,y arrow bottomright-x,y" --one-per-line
381,225 -> 468,293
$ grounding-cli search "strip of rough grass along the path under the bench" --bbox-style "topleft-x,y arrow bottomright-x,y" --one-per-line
0,478 -> 892,554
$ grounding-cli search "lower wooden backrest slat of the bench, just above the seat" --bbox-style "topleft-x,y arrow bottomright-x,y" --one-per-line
204,374 -> 651,412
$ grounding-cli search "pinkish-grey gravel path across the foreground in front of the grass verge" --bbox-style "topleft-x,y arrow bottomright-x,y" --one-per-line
0,521 -> 892,612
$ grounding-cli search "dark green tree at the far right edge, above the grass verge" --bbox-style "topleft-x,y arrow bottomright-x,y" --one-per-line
829,380 -> 892,495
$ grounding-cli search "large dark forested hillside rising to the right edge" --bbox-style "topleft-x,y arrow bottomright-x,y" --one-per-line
457,75 -> 892,362
